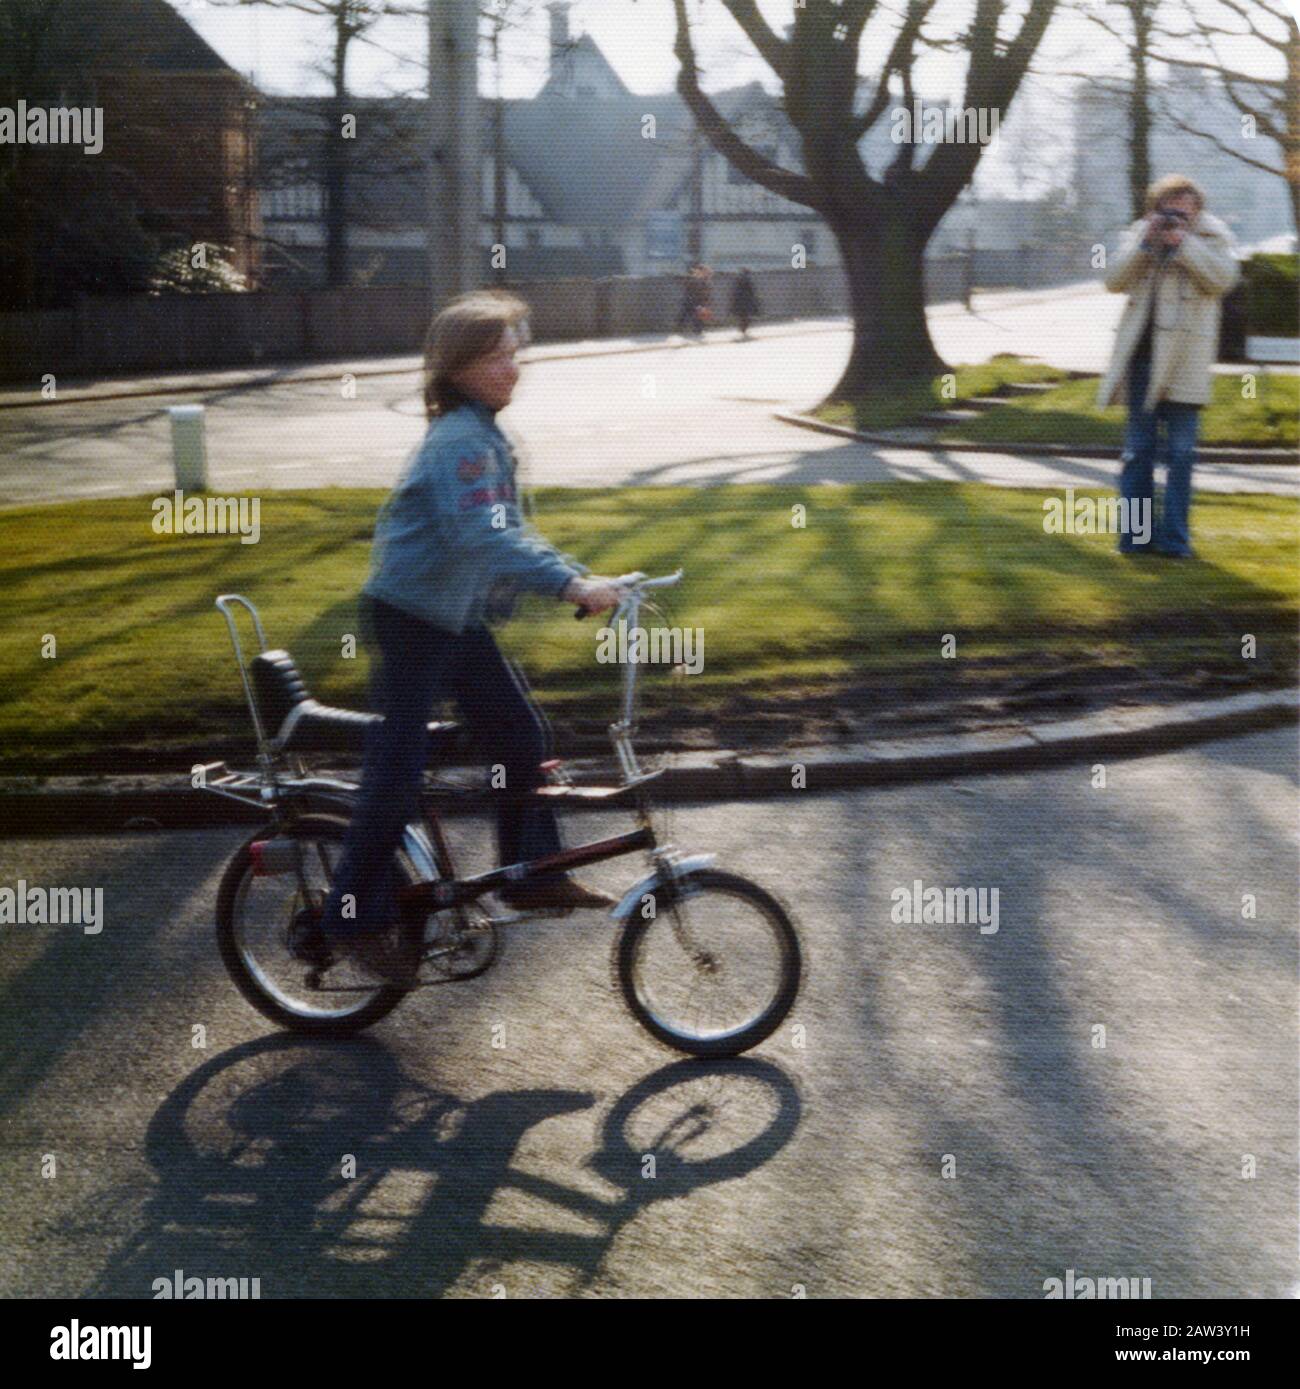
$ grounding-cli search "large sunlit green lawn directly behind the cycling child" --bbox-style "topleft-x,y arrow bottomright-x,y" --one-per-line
0,483 -> 1300,772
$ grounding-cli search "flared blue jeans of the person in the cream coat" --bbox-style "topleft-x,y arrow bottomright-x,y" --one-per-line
1119,354 -> 1200,554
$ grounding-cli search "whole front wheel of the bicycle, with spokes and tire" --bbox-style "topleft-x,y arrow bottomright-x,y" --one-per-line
615,868 -> 803,1057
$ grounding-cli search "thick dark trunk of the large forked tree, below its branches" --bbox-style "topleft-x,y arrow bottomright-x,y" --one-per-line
828,201 -> 947,400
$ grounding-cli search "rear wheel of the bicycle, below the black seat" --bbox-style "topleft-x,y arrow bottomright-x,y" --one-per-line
217,815 -> 422,1036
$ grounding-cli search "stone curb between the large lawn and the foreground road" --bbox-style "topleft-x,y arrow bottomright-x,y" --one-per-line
0,689 -> 1300,838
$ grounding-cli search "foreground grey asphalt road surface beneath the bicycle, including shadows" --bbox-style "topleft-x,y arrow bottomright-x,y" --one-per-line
0,729 -> 1297,1299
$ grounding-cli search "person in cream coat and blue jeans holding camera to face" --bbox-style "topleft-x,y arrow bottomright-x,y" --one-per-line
1097,174 -> 1240,558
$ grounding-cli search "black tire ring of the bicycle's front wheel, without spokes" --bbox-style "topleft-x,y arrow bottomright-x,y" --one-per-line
614,868 -> 803,1057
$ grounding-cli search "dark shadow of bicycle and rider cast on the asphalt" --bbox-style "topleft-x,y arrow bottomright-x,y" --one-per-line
85,1035 -> 800,1299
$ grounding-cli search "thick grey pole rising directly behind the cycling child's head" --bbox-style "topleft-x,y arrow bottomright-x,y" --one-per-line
426,0 -> 482,313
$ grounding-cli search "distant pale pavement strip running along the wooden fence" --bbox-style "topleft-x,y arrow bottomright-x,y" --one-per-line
0,281 -> 1104,410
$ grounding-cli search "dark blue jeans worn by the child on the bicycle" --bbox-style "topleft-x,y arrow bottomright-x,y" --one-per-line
321,597 -> 563,932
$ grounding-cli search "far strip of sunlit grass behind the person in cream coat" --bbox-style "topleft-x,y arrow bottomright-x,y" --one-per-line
939,372 -> 1300,449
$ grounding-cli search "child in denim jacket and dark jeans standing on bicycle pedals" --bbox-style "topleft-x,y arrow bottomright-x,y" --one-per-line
313,292 -> 621,983
